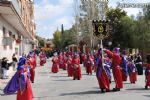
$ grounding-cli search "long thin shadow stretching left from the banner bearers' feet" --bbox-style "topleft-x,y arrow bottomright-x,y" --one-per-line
60,90 -> 101,96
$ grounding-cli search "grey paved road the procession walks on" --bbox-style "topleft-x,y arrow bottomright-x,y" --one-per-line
0,60 -> 150,100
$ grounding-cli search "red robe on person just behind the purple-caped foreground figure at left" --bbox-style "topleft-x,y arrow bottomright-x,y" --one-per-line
30,58 -> 36,82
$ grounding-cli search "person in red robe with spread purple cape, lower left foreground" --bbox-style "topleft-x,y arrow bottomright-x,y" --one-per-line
3,57 -> 33,100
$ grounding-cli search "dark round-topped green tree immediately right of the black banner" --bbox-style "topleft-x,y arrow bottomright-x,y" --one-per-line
106,8 -> 128,47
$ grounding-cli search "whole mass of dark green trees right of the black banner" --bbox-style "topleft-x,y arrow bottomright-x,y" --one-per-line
107,8 -> 150,49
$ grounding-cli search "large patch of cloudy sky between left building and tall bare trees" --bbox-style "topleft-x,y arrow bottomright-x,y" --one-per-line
35,0 -> 74,38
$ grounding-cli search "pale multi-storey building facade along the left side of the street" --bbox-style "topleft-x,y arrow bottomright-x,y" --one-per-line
0,0 -> 36,60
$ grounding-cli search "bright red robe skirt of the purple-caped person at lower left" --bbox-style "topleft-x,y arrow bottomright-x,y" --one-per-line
17,69 -> 33,100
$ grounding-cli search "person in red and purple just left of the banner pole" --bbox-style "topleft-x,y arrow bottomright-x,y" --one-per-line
96,48 -> 110,93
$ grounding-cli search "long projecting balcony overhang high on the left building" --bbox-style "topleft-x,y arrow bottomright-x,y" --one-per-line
0,0 -> 33,40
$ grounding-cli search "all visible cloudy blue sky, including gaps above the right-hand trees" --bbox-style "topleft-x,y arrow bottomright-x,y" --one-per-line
34,0 -> 149,38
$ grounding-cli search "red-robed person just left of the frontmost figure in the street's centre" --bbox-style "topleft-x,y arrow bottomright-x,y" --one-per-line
67,55 -> 73,77
